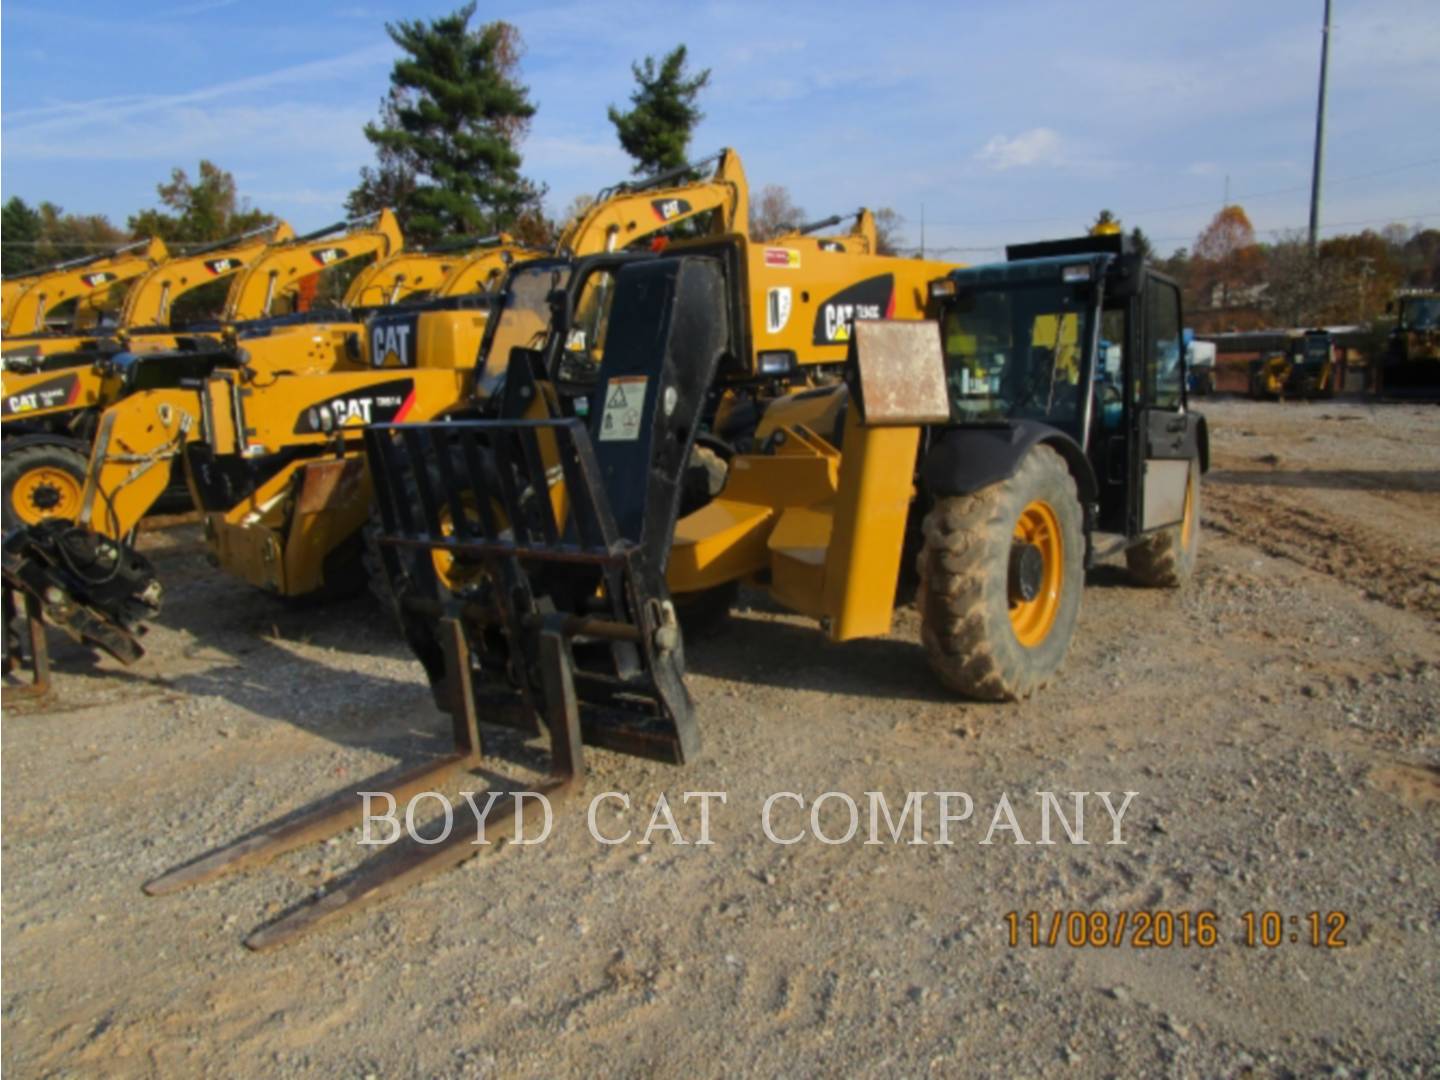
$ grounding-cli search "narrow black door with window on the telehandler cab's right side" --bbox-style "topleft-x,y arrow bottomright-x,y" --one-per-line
1130,274 -> 1200,533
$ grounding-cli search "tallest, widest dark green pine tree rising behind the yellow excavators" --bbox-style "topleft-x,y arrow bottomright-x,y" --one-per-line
348,3 -> 543,243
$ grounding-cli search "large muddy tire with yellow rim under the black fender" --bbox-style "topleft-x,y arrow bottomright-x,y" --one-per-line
919,445 -> 1084,701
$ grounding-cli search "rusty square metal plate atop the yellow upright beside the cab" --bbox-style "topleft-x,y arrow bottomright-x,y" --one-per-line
850,318 -> 950,428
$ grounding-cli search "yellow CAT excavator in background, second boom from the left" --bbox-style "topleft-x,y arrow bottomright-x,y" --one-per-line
4,222 -> 295,361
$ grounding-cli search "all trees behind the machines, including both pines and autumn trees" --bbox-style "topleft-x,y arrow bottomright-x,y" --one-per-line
0,3 -> 1440,331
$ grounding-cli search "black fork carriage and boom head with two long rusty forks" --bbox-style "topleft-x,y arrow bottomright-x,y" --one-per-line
145,258 -> 729,949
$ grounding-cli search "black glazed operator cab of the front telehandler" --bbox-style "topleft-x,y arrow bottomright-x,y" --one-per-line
930,235 -> 1205,537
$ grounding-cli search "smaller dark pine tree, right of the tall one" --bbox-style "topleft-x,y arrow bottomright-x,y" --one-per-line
608,45 -> 710,176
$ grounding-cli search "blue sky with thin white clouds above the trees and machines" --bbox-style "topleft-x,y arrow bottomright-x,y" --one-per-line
0,0 -> 1440,262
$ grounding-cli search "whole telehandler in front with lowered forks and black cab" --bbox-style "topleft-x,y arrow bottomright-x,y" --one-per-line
123,226 -> 1208,949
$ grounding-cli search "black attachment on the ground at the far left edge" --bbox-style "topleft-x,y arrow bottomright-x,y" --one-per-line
3,520 -> 161,667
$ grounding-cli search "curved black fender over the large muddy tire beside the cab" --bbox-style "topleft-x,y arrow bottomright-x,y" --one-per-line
920,420 -> 1100,505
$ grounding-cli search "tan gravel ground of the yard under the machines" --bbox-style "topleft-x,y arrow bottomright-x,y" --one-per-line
0,400 -> 1440,1077
